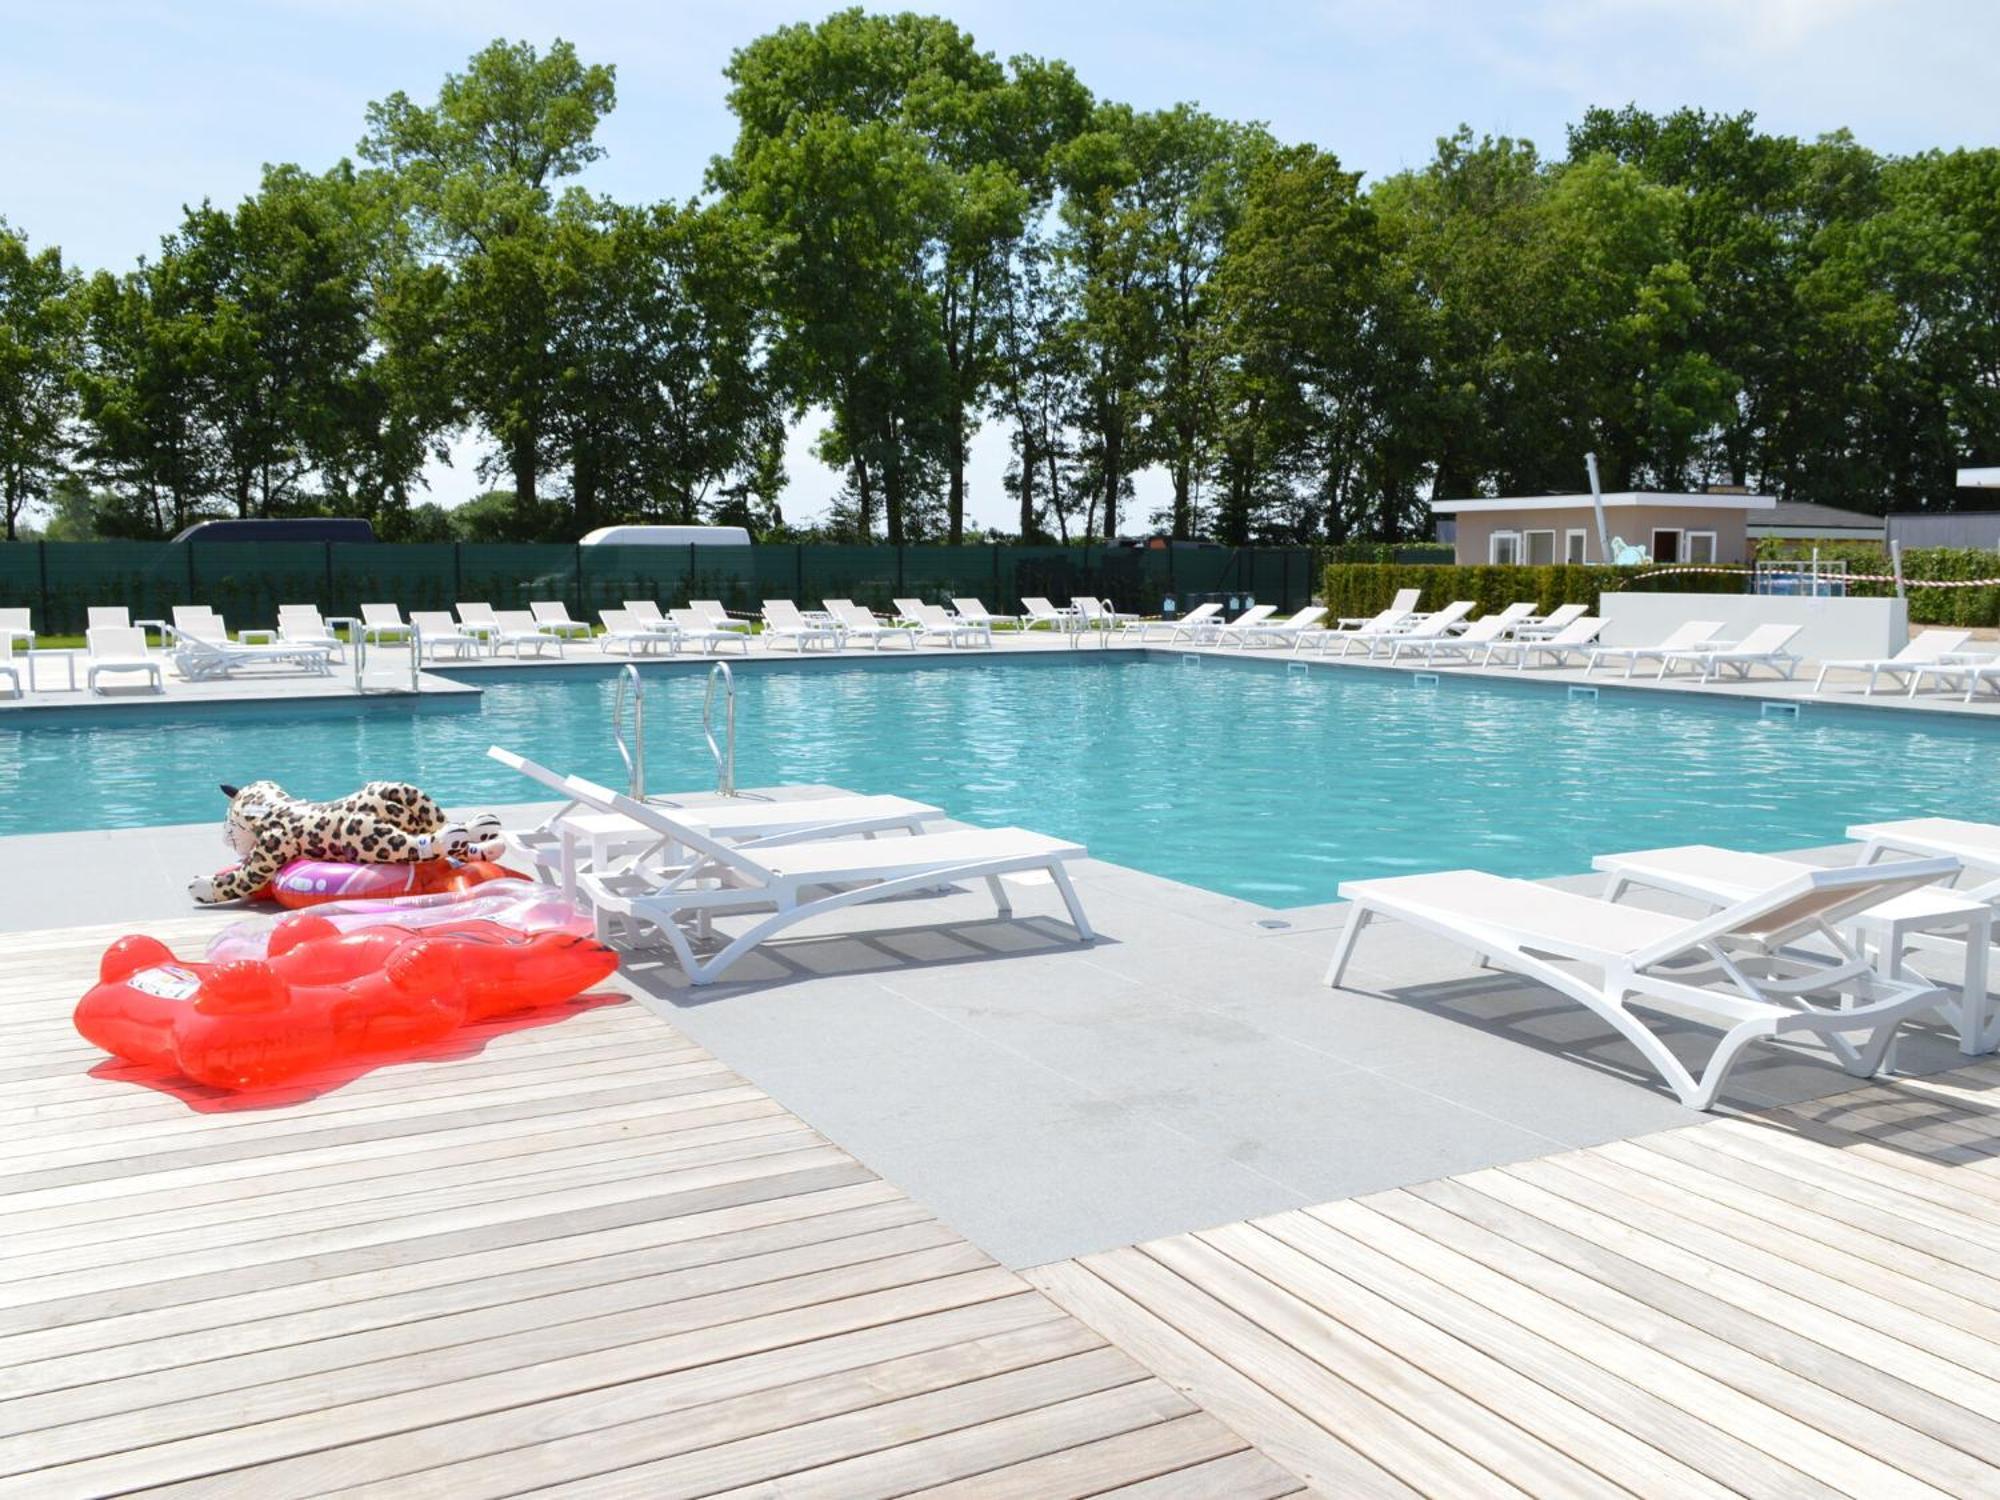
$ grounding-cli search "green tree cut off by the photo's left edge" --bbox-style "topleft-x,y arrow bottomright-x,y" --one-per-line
0,218 -> 82,542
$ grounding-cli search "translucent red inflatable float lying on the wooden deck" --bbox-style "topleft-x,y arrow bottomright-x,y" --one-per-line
76,916 -> 618,1088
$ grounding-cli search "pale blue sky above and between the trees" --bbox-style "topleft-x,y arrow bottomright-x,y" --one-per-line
0,0 -> 2000,524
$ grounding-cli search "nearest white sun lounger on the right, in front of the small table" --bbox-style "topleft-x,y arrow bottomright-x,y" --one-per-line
1326,860 -> 1952,1110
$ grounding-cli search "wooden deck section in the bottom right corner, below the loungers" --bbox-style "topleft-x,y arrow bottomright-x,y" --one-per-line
1028,1062 -> 2000,1500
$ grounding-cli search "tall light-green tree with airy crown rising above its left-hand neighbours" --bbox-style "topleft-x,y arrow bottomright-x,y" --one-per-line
360,40 -> 616,510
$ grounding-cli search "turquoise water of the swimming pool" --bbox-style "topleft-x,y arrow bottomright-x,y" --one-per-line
0,656 -> 2000,906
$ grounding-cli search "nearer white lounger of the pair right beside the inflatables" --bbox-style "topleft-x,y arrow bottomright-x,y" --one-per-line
578,792 -> 1092,984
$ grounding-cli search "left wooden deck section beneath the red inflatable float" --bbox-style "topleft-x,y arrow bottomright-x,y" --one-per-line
0,920 -> 1302,1500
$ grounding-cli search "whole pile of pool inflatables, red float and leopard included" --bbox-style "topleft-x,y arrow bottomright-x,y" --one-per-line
76,782 -> 618,1088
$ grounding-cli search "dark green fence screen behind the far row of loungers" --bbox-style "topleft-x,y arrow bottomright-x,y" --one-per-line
0,542 -> 1320,634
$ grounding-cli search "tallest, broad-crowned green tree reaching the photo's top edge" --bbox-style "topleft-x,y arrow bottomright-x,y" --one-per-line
710,10 -> 1088,542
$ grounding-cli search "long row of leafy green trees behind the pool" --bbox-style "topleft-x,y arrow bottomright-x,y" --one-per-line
0,39 -> 2000,548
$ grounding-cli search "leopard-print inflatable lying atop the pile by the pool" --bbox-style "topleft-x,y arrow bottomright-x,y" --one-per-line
188,782 -> 502,906
